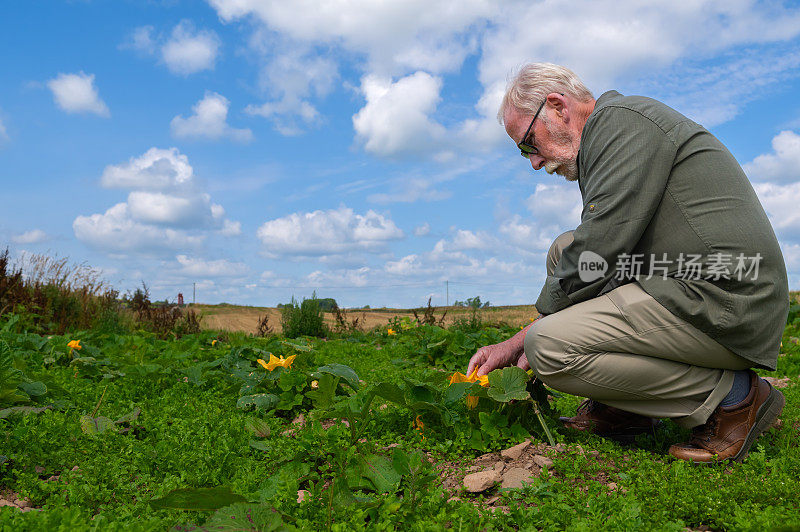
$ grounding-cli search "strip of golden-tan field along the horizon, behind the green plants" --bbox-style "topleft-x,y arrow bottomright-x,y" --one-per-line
192,305 -> 538,333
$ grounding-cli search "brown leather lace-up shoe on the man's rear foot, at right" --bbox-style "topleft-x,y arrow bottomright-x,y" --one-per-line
669,370 -> 786,462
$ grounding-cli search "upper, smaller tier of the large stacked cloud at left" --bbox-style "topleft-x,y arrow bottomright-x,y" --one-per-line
100,148 -> 193,190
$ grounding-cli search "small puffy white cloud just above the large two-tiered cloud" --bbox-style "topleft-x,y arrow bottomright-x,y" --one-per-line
170,92 -> 253,142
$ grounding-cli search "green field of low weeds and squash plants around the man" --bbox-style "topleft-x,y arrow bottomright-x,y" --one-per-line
0,315 -> 800,531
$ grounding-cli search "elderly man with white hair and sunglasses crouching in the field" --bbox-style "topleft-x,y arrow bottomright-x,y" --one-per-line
467,63 -> 789,462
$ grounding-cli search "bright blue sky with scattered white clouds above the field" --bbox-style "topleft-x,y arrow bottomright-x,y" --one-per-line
0,0 -> 800,307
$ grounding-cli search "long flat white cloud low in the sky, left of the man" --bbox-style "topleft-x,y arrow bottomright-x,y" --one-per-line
257,207 -> 404,256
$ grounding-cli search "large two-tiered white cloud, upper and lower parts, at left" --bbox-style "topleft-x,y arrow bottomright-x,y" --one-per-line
73,148 -> 241,252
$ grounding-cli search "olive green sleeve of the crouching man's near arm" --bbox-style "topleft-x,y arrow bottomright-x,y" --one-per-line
536,106 -> 676,314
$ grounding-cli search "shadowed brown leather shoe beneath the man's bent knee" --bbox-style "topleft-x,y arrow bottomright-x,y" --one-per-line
559,399 -> 659,442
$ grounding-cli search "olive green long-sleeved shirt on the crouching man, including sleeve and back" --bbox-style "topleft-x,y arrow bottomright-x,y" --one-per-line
536,91 -> 789,370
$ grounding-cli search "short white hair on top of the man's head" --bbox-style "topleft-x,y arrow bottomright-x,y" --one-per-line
497,63 -> 594,124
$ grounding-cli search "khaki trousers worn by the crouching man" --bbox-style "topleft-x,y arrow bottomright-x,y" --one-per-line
525,231 -> 752,428
